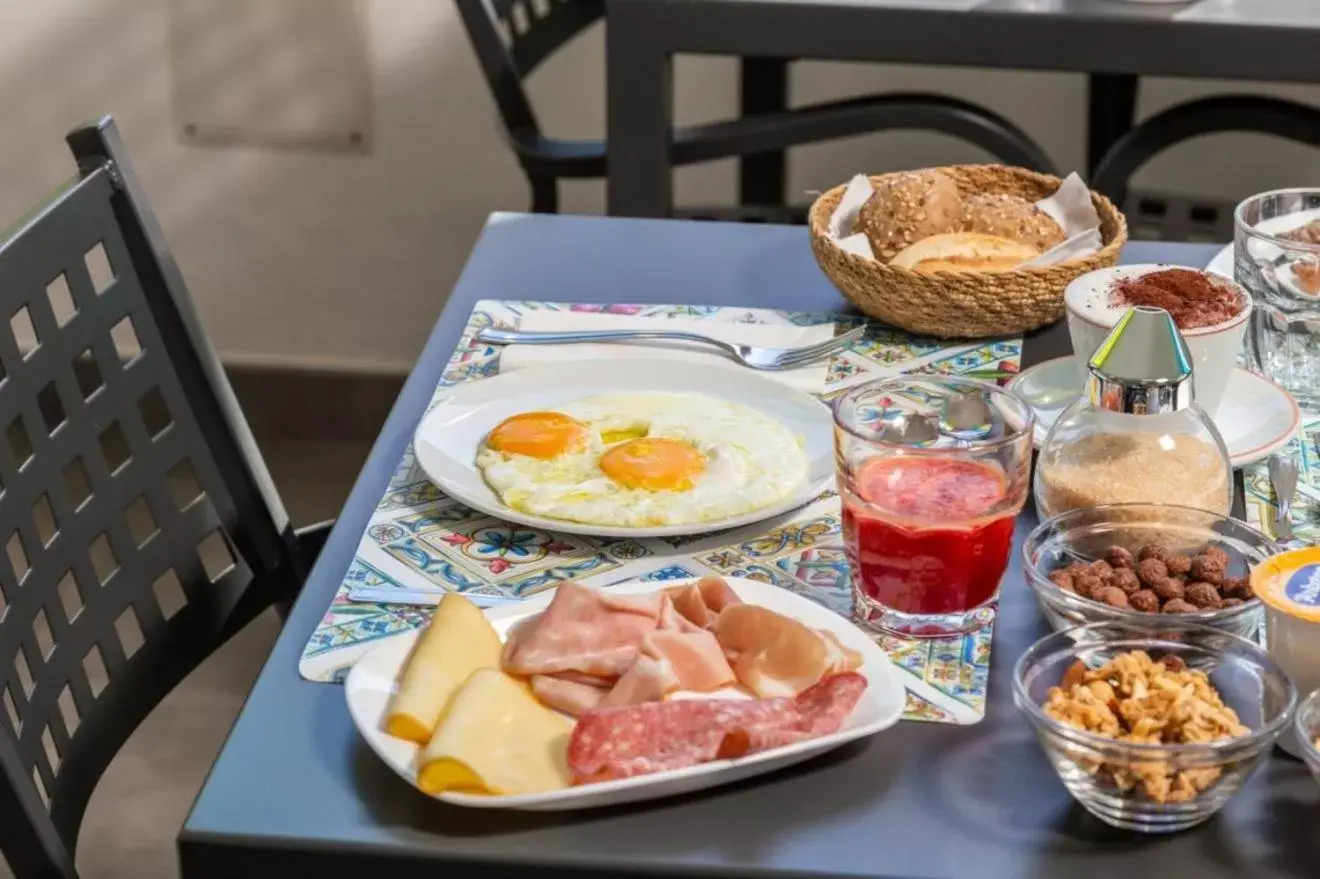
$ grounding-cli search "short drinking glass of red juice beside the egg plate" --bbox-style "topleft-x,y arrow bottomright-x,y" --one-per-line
834,376 -> 1035,637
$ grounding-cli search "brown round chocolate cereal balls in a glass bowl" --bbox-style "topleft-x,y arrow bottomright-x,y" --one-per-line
1048,544 -> 1255,614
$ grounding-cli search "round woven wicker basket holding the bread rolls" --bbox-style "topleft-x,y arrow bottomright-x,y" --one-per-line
808,165 -> 1127,338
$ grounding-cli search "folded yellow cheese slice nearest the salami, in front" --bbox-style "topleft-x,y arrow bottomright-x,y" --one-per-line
417,668 -> 573,795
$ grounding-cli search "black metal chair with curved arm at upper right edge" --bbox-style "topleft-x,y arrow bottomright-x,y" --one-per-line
1090,95 -> 1320,240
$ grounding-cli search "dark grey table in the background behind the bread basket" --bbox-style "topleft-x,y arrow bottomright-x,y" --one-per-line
606,0 -> 1320,216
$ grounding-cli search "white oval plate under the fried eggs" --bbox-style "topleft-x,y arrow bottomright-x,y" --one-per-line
413,360 -> 834,537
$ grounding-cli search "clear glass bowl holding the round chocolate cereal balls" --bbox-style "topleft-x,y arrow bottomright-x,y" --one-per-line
1022,504 -> 1279,640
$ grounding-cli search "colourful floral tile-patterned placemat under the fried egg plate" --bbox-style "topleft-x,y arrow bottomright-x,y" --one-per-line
298,301 -> 1022,723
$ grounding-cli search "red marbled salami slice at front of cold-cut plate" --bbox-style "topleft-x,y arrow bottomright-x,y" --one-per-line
568,672 -> 866,784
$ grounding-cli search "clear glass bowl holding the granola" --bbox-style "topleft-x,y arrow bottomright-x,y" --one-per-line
1012,615 -> 1298,833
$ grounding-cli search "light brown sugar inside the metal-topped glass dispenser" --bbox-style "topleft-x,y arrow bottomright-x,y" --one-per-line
1036,430 -> 1233,516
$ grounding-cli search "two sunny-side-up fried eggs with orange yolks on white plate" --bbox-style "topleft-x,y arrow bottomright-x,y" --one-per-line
477,392 -> 808,528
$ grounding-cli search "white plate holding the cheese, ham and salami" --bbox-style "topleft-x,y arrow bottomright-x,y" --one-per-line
345,577 -> 907,812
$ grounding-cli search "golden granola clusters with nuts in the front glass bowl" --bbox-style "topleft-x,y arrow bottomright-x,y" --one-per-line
1044,651 -> 1250,802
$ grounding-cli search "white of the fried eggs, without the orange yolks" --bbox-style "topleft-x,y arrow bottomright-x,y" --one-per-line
477,392 -> 808,528
